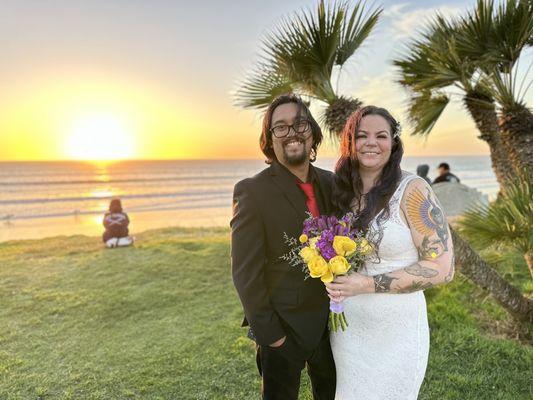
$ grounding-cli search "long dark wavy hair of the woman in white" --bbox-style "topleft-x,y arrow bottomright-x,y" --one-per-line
332,106 -> 403,232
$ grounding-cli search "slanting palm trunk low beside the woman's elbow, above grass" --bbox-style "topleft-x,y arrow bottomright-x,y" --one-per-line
450,227 -> 533,323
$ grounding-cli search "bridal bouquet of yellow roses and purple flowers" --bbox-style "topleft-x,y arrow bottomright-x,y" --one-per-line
282,213 -> 374,332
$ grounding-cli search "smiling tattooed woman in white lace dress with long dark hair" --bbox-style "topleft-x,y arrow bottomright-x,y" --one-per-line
326,106 -> 453,400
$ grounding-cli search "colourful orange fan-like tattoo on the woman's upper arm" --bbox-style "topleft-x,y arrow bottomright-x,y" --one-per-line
406,188 -> 448,255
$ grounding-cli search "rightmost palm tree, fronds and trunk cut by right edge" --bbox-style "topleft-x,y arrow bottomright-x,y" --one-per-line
459,0 -> 533,177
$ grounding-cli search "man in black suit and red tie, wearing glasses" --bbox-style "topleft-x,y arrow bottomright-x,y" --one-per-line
231,94 -> 335,400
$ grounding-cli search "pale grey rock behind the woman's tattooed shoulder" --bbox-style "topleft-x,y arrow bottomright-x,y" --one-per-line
432,182 -> 489,218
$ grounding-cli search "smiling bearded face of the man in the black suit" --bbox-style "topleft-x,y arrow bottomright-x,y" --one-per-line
271,103 -> 313,165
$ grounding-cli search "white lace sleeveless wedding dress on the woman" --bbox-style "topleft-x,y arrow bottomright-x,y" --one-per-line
330,172 -> 429,400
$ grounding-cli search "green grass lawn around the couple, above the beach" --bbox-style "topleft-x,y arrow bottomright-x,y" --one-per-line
0,228 -> 533,400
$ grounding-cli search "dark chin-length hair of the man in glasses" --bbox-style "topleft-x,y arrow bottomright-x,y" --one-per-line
259,93 -> 322,164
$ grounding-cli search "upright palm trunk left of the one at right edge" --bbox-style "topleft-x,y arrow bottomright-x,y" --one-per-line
463,92 -> 515,188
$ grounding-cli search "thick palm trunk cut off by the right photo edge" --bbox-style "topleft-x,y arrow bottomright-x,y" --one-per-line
499,105 -> 533,177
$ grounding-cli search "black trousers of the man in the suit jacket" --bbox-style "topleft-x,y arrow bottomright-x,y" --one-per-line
256,330 -> 336,400
